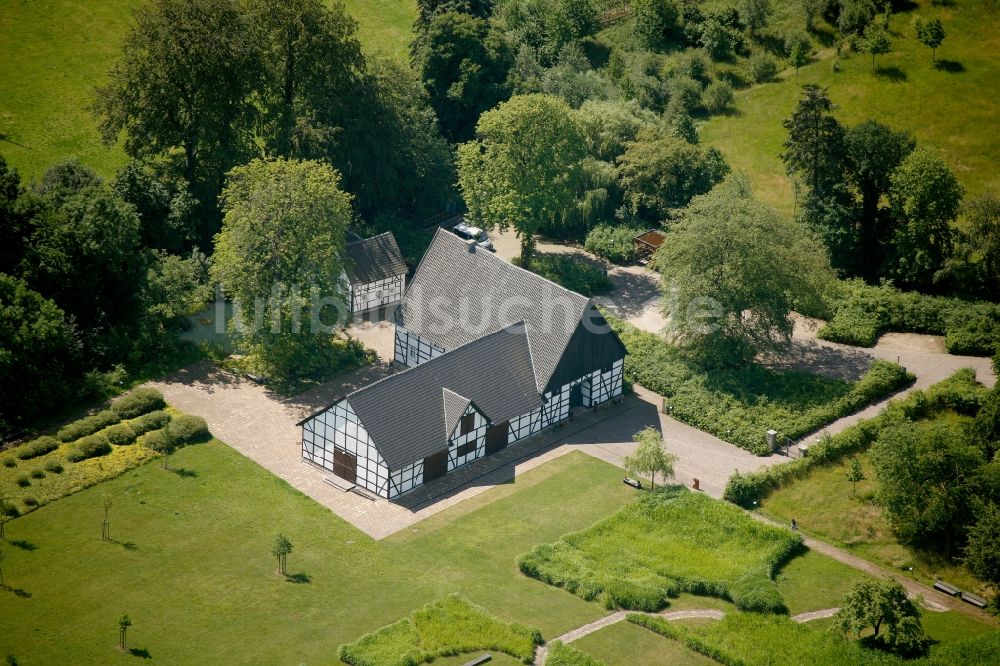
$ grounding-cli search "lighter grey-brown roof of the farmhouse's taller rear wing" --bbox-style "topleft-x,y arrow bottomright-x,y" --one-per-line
395,229 -> 590,394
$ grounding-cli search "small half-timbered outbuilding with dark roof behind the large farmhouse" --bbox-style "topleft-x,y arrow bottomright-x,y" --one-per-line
345,231 -> 406,313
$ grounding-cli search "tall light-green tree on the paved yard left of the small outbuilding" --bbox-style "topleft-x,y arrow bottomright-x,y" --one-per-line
211,159 -> 351,379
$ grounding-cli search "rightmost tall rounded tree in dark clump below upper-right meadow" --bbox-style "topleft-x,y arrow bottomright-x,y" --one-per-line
889,150 -> 964,289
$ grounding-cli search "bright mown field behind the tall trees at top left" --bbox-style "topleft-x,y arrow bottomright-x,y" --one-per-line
0,0 -> 416,178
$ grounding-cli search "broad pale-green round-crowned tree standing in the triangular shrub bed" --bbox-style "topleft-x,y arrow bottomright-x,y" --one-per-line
656,177 -> 833,364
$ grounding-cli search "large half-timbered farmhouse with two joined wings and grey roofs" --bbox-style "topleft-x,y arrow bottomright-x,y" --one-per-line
300,230 -> 625,498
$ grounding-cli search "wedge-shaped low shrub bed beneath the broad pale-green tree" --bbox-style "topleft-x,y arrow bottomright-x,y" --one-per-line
608,317 -> 914,455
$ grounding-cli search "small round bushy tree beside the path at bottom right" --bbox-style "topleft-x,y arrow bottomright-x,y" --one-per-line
834,579 -> 926,655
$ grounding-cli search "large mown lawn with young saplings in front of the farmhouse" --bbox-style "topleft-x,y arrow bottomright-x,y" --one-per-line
0,442 -> 634,663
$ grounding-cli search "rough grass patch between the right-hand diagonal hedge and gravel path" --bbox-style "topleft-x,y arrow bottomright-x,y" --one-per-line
761,413 -> 987,594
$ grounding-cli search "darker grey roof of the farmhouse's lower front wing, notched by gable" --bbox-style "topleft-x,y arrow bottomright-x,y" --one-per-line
345,322 -> 542,470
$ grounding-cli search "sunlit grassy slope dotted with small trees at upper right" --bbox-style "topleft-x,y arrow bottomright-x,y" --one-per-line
701,0 -> 1000,212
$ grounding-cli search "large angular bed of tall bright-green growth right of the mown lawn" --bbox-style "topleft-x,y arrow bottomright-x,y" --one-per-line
517,487 -> 802,612
